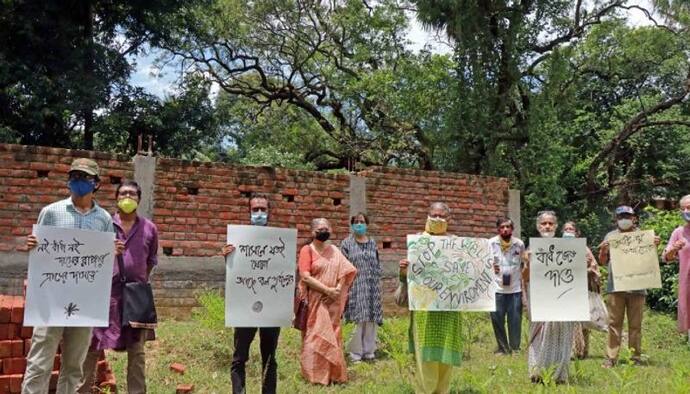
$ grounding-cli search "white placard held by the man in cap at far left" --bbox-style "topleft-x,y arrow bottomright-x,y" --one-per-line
24,225 -> 115,327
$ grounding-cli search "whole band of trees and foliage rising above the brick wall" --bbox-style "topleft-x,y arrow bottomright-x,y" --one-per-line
0,0 -> 690,235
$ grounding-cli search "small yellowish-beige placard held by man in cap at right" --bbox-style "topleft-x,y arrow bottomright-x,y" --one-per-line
608,230 -> 661,291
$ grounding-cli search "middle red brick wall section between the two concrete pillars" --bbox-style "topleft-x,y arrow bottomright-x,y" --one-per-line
154,159 -> 349,256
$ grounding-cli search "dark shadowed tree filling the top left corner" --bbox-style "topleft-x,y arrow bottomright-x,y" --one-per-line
0,0 -> 199,149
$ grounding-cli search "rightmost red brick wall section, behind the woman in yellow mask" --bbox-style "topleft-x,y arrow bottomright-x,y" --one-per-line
359,167 -> 508,260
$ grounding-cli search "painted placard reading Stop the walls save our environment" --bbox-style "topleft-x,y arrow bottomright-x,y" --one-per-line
407,234 -> 498,311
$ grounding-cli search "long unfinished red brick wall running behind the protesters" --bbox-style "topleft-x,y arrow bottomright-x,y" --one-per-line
0,144 -> 509,317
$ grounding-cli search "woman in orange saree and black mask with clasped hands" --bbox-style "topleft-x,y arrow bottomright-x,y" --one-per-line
299,218 -> 357,385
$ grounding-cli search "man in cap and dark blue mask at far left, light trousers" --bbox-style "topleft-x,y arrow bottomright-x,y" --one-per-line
22,158 -> 124,394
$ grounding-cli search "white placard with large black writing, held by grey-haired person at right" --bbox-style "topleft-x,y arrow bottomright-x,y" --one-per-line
529,238 -> 589,321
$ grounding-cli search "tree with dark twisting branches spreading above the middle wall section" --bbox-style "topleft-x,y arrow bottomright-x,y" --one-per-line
159,0 -> 448,168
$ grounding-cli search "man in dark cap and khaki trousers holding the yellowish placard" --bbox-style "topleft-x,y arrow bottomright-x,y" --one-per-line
599,205 -> 660,368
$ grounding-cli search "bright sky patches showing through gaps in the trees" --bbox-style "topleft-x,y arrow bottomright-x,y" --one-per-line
130,0 -> 661,98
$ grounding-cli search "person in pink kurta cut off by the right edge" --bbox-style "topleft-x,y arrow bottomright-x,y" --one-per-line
664,195 -> 690,339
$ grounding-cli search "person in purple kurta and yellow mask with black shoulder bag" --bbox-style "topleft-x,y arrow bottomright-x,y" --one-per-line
79,181 -> 158,394
